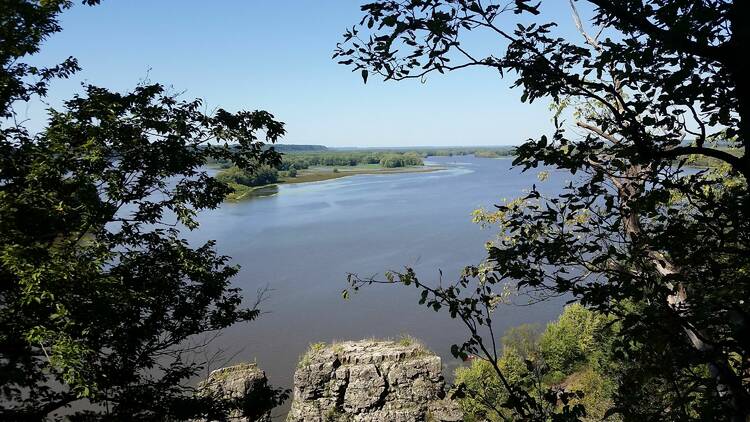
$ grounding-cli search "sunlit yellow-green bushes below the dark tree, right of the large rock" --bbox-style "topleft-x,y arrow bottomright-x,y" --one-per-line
455,304 -> 619,422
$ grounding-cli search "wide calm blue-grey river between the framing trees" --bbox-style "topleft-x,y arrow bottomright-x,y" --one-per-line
186,156 -> 568,416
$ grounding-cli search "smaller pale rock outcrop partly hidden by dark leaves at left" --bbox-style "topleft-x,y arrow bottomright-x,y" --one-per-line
202,363 -> 271,422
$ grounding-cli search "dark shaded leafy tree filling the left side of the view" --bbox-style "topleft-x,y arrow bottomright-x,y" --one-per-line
0,0 -> 284,420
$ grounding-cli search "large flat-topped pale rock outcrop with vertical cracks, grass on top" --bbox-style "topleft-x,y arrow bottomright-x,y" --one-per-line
287,340 -> 462,422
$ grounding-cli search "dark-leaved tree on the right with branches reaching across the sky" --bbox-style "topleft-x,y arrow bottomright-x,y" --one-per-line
344,0 -> 750,421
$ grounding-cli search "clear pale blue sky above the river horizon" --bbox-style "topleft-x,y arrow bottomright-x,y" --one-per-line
21,0 -> 592,147
